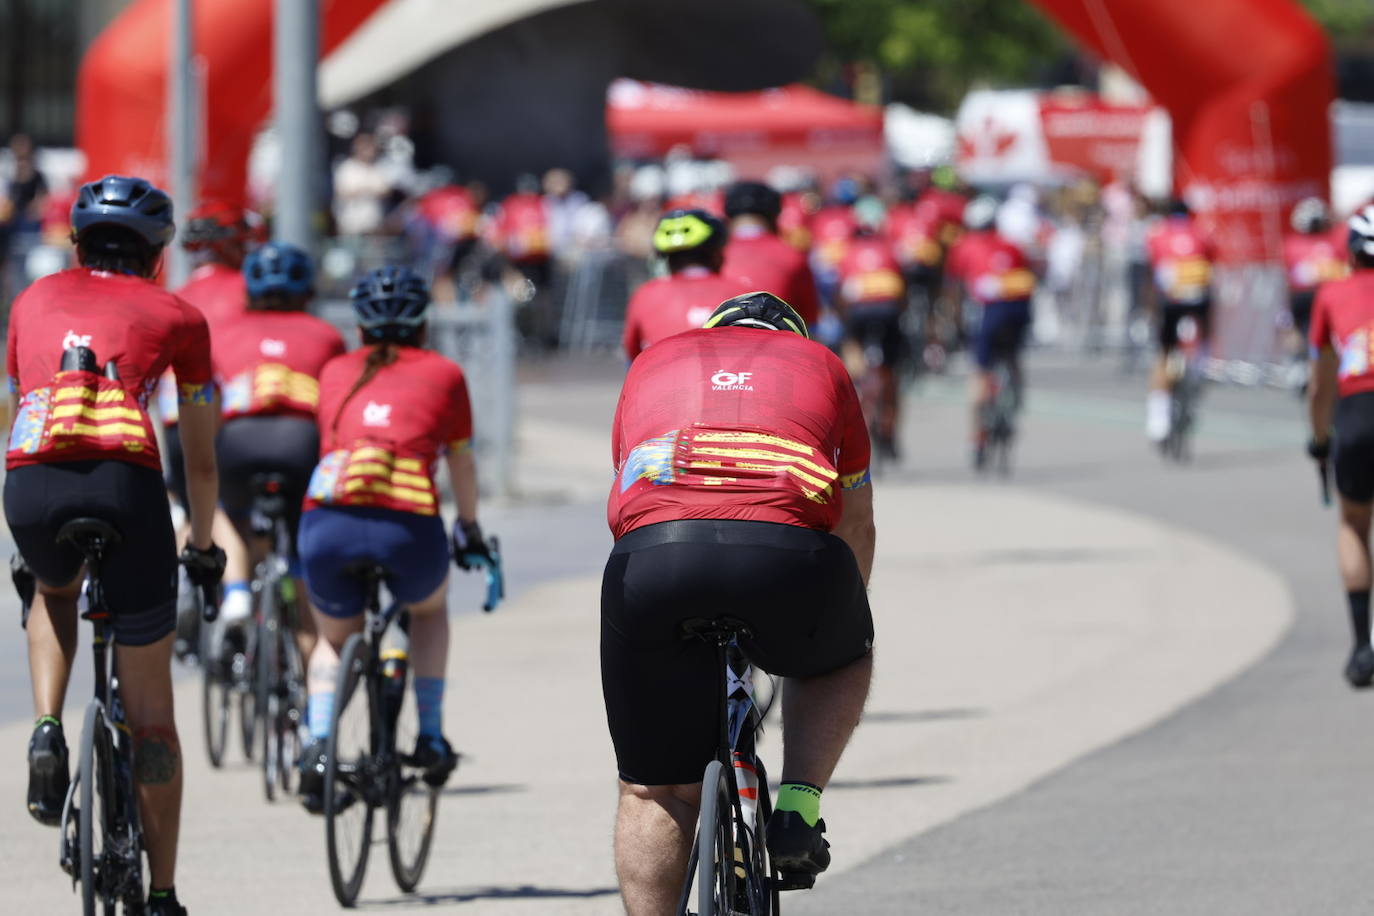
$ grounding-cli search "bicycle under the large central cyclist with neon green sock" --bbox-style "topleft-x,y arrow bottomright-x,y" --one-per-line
677,618 -> 796,916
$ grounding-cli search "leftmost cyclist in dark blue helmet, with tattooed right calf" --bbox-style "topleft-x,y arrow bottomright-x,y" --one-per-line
4,176 -> 224,915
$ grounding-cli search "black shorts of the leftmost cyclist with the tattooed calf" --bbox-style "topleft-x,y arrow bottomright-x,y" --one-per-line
4,461 -> 176,645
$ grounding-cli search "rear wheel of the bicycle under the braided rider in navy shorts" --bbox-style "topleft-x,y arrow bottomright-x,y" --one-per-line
324,633 -> 378,906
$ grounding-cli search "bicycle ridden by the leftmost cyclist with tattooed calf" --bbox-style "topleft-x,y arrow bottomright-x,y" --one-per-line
58,518 -> 216,916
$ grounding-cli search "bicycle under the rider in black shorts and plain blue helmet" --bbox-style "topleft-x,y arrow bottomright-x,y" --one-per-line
249,472 -> 305,802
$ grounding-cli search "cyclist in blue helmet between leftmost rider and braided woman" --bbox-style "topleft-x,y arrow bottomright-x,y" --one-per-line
214,242 -> 346,648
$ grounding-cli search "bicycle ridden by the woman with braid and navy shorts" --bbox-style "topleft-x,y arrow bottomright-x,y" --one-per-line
323,563 -> 441,906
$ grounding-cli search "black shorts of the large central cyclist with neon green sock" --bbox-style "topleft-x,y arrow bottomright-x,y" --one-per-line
602,519 -> 872,786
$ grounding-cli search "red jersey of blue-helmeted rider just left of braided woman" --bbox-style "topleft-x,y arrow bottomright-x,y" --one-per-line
214,310 -> 346,419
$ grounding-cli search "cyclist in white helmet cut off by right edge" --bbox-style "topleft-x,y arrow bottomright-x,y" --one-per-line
1308,206 -> 1374,687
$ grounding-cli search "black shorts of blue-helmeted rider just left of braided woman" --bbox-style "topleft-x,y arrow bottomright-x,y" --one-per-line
214,416 -> 320,544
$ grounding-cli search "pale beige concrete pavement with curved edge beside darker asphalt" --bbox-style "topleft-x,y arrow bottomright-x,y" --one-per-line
0,362 -> 1290,916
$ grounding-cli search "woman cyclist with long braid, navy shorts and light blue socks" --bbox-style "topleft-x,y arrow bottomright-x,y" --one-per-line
301,266 -> 491,810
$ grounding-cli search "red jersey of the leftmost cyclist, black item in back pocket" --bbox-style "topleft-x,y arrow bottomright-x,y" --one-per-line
5,268 -> 214,468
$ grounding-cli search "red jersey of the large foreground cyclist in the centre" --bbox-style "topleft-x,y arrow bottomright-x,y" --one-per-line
607,327 -> 868,538
